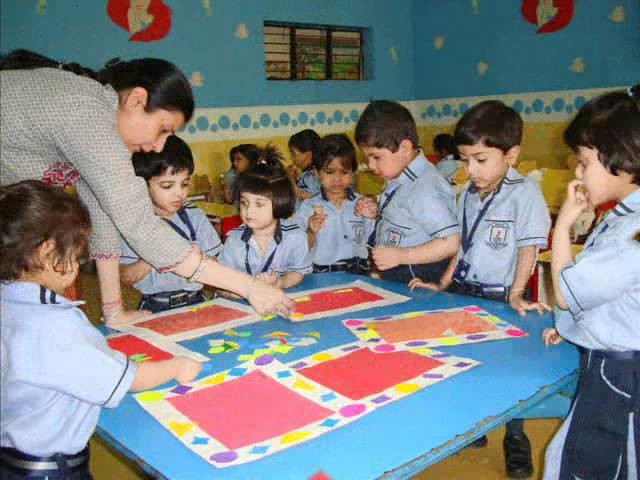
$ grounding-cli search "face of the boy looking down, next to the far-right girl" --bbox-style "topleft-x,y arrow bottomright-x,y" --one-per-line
458,142 -> 520,194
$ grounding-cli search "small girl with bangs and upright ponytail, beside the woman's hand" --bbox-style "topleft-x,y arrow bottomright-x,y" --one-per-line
218,147 -> 312,289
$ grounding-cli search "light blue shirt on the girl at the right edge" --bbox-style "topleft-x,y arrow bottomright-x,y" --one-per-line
555,190 -> 640,351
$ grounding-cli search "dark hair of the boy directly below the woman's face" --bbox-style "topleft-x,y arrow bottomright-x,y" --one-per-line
131,135 -> 195,183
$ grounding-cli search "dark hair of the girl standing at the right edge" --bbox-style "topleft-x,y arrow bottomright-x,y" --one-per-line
564,84 -> 640,185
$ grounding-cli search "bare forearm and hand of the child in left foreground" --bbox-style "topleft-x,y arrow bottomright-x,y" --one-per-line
129,357 -> 202,392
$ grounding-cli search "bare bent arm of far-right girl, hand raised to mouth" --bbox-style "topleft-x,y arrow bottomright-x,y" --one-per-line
551,180 -> 589,310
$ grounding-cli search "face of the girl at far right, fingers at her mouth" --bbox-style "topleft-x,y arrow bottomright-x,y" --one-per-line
576,147 -> 633,207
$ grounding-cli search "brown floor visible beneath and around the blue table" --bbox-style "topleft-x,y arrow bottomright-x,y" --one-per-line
81,273 -> 560,480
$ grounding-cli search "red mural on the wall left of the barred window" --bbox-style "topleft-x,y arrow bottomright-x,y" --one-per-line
107,0 -> 172,42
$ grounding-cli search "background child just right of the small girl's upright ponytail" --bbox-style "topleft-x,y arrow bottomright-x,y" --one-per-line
289,128 -> 320,201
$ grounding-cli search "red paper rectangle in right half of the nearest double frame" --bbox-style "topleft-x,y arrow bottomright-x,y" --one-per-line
298,348 -> 443,400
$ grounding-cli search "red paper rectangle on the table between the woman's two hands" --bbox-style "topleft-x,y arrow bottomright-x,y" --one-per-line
136,305 -> 249,335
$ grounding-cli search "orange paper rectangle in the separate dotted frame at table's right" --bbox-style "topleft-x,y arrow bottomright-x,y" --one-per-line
367,312 -> 498,343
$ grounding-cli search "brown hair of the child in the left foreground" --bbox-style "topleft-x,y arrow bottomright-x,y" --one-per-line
0,180 -> 91,282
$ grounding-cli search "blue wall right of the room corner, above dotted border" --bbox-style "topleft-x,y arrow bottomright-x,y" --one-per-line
414,0 -> 640,99
